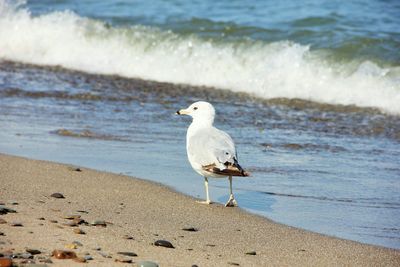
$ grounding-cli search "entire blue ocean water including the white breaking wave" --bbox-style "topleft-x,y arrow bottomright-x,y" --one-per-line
0,0 -> 400,249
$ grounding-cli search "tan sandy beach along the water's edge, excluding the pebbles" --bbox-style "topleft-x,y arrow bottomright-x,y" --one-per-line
0,154 -> 400,267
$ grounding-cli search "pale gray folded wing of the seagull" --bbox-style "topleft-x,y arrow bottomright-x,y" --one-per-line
188,127 -> 236,170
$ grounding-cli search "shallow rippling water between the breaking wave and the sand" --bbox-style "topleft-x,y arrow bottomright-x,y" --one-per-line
0,62 -> 400,248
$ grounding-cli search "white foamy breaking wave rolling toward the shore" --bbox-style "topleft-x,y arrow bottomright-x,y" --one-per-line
0,0 -> 400,114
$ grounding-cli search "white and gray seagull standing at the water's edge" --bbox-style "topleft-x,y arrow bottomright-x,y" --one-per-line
176,101 -> 249,207
